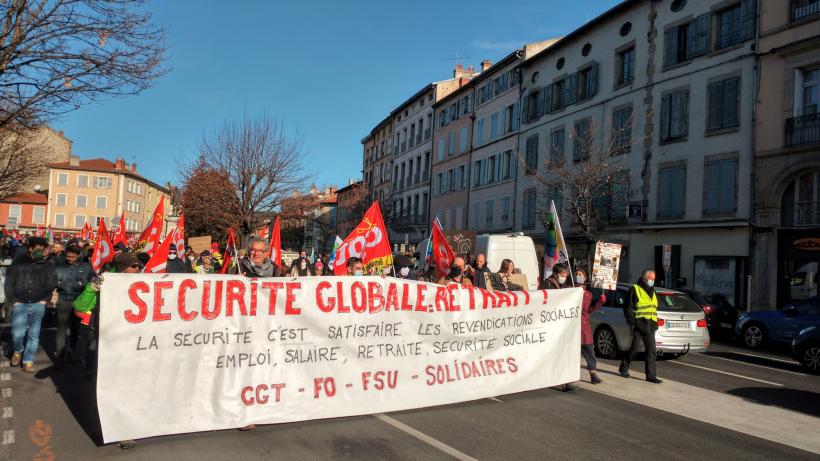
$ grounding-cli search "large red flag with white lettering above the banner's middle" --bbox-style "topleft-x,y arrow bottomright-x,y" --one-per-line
333,202 -> 393,275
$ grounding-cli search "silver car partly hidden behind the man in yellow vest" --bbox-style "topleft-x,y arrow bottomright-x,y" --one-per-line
590,283 -> 711,359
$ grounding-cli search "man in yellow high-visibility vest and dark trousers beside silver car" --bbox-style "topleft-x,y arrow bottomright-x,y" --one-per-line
619,269 -> 663,384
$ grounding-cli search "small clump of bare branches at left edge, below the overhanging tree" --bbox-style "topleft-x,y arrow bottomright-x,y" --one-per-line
0,129 -> 50,200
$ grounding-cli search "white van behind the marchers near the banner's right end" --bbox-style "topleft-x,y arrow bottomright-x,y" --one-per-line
474,232 -> 538,290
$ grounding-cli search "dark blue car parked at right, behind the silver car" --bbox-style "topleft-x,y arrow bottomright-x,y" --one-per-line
735,296 -> 820,348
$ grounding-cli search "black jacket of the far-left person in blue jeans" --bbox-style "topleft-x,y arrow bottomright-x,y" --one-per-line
4,255 -> 57,304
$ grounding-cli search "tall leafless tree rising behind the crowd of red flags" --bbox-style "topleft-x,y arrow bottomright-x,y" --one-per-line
192,115 -> 308,246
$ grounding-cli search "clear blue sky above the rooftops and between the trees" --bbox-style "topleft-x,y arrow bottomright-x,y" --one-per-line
52,0 -> 618,187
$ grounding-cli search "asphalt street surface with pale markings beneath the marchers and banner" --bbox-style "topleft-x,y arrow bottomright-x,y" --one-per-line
0,320 -> 820,461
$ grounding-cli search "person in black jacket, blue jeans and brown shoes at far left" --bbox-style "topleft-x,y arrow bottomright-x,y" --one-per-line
4,237 -> 57,373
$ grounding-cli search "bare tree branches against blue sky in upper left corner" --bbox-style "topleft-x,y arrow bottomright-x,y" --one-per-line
0,0 -> 166,129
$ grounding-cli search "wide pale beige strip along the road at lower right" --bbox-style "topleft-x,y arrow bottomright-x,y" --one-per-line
577,363 -> 820,454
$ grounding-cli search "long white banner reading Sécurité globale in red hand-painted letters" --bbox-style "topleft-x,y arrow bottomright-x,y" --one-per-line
97,273 -> 582,443
